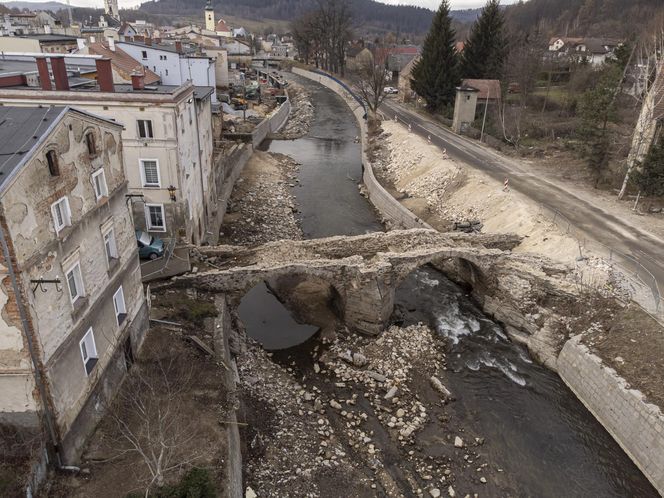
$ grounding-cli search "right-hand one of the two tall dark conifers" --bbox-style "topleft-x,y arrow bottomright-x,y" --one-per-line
461,0 -> 507,80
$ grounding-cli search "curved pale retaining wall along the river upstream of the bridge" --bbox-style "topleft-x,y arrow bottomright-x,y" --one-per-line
292,67 -> 431,228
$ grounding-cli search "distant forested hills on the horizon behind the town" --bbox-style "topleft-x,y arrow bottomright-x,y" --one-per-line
140,0 -> 433,33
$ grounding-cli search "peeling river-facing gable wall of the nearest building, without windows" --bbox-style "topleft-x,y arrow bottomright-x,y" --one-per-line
0,114 -> 147,456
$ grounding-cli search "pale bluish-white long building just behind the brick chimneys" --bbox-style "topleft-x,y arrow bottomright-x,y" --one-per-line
115,39 -> 218,105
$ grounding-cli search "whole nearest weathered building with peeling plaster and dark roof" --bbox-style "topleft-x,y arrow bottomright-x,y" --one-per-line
0,105 -> 148,464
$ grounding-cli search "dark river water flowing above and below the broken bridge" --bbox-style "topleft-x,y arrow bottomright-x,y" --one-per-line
240,72 -> 658,498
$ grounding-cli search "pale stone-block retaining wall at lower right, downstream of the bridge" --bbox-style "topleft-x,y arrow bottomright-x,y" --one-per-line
558,336 -> 664,495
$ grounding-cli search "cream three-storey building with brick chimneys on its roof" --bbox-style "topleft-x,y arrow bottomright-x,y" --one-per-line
0,55 -> 217,244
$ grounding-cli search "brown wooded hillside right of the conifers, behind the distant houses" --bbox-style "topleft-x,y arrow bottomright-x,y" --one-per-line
506,0 -> 664,37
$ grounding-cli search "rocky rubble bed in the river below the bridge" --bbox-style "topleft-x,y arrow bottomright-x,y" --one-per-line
238,325 -> 487,497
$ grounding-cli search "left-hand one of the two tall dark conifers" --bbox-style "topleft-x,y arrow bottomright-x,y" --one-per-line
411,0 -> 459,112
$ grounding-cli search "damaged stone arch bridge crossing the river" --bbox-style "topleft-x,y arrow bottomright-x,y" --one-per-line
165,229 -> 573,344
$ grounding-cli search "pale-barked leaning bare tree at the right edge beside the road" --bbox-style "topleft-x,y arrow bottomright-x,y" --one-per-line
618,29 -> 664,199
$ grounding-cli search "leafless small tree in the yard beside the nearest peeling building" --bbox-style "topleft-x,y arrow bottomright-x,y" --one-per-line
108,358 -> 209,497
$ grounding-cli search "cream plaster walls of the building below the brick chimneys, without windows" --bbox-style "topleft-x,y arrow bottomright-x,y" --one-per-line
0,83 -> 217,244
